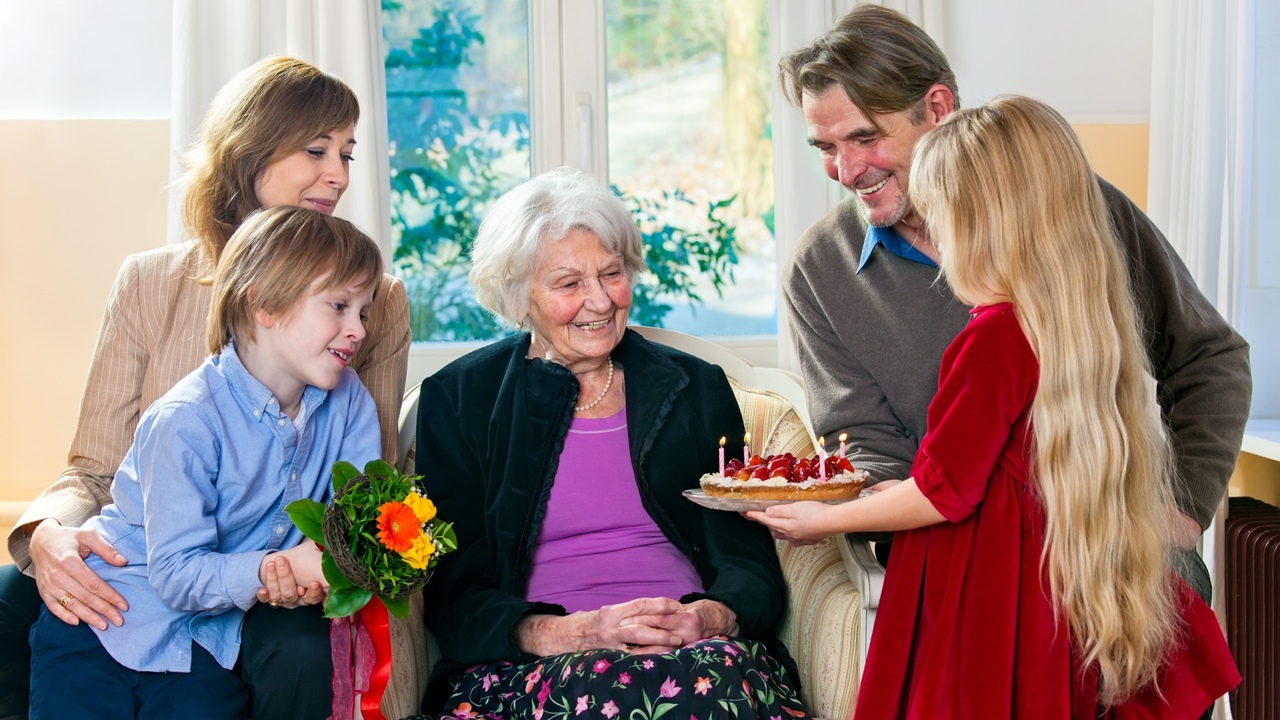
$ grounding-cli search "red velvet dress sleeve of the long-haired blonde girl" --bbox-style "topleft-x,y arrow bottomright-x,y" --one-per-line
911,306 -> 1039,523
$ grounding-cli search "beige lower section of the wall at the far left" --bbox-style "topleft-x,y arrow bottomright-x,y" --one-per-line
0,119 -> 169,509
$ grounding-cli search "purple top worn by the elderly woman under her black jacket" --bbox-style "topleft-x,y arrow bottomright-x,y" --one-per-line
525,409 -> 703,612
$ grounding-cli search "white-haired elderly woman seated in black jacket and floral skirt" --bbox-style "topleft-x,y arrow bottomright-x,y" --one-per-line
417,169 -> 805,719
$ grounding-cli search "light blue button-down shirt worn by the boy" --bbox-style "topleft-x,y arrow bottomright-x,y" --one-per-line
86,345 -> 381,673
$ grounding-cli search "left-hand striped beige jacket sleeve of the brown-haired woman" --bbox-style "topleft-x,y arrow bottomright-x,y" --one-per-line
9,256 -> 154,571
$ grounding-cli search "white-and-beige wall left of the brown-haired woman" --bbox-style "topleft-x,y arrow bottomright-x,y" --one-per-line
0,0 -> 172,548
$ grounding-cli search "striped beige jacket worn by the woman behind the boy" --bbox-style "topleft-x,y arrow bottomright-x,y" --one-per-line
9,245 -> 410,571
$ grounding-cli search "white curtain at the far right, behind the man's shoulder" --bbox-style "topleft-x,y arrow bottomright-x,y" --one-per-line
1147,0 -> 1256,327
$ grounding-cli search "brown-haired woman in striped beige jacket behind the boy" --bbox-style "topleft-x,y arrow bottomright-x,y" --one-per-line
0,58 -> 410,717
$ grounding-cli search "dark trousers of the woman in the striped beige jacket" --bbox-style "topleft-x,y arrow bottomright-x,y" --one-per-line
0,565 -> 333,720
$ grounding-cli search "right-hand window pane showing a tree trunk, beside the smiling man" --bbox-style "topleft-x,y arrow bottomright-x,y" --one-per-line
605,0 -> 777,334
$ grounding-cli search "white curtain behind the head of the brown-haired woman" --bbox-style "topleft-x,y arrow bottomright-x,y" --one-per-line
169,0 -> 390,258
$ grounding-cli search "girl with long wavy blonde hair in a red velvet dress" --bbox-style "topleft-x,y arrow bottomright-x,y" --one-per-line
748,96 -> 1240,720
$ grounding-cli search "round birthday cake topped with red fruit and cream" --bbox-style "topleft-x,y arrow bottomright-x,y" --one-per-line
700,452 -> 867,501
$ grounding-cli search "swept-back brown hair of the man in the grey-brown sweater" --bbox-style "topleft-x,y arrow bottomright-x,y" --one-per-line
778,5 -> 960,124
